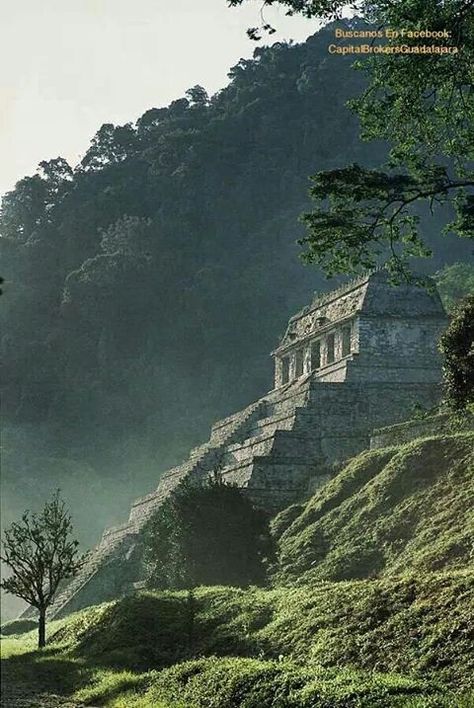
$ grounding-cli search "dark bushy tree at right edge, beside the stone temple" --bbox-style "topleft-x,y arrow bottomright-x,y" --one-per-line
440,295 -> 474,411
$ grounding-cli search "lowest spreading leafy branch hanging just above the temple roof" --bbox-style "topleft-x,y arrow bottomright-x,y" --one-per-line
299,164 -> 474,279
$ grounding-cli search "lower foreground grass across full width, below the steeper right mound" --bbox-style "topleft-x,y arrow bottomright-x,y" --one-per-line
3,571 -> 474,708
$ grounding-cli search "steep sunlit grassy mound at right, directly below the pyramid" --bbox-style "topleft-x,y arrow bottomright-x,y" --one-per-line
274,433 -> 474,583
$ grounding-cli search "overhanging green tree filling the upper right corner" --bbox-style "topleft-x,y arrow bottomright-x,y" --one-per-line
230,0 -> 474,280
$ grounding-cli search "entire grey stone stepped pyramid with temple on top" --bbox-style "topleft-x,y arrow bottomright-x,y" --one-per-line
40,271 -> 446,617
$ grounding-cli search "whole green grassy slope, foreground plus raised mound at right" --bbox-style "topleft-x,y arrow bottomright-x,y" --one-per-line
2,433 -> 474,708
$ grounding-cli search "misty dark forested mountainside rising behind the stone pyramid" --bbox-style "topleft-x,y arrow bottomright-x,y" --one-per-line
0,19 -> 470,542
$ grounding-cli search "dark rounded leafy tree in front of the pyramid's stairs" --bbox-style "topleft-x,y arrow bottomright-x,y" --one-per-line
144,474 -> 273,588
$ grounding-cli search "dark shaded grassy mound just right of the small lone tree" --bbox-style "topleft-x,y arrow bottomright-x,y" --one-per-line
50,592 -> 272,671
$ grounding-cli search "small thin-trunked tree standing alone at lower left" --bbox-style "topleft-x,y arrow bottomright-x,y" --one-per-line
0,490 -> 84,647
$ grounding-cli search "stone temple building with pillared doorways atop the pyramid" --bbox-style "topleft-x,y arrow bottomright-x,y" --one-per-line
273,271 -> 446,388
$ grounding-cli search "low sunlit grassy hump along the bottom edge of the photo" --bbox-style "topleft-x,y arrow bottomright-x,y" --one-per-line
116,657 -> 449,708
